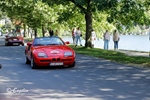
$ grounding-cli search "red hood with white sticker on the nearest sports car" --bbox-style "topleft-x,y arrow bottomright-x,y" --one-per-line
35,45 -> 73,56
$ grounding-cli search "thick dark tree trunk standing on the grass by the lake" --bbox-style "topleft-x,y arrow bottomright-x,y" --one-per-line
85,12 -> 92,48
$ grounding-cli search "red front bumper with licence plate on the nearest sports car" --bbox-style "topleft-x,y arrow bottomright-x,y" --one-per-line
34,57 -> 75,66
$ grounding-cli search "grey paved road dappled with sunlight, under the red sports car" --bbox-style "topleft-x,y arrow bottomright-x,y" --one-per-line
0,38 -> 150,100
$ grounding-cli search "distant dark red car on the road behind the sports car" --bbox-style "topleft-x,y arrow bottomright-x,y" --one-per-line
5,33 -> 24,46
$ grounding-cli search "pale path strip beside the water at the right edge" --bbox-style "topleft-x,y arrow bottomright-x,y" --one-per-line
117,50 -> 149,57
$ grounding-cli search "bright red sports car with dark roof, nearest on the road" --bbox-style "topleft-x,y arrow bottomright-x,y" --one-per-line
25,36 -> 75,69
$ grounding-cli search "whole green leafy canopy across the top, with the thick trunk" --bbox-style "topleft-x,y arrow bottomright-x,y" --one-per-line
0,0 -> 150,47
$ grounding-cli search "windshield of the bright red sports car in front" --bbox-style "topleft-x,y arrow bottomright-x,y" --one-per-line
33,37 -> 64,46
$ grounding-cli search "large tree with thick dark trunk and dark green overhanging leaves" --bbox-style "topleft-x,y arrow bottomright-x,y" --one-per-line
43,0 -> 149,47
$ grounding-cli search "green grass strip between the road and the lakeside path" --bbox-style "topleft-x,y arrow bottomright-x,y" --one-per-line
69,45 -> 150,68
